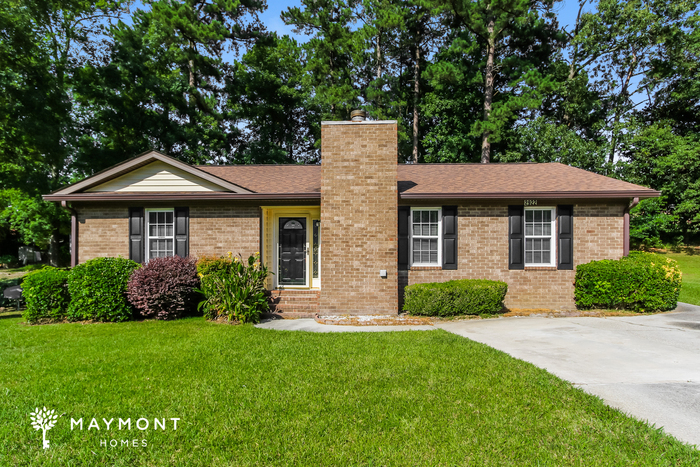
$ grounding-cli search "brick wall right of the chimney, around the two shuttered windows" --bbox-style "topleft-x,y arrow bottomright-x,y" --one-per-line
403,204 -> 624,310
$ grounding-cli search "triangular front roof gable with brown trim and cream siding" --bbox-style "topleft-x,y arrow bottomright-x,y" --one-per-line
52,151 -> 251,196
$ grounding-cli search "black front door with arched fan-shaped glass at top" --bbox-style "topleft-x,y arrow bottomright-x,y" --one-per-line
277,217 -> 306,285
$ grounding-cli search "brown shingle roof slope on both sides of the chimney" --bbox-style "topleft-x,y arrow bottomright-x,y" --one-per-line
198,162 -> 658,198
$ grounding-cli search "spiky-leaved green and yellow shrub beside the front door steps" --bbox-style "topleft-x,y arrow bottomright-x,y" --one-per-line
197,253 -> 270,323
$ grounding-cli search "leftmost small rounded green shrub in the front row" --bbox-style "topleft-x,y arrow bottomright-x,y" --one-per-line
22,266 -> 70,323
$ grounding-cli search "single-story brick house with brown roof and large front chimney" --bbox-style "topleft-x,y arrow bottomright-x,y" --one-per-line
45,115 -> 659,317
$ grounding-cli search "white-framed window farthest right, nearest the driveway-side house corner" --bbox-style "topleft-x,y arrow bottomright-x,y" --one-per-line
525,208 -> 556,266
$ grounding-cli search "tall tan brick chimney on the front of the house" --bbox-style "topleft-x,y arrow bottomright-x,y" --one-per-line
319,122 -> 398,314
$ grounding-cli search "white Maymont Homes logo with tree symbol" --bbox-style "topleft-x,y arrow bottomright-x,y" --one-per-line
30,407 -> 180,449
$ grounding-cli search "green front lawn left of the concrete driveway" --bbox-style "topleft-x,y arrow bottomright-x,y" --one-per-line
0,315 -> 700,466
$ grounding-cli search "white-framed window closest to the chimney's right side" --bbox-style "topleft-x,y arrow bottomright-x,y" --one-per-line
411,208 -> 442,266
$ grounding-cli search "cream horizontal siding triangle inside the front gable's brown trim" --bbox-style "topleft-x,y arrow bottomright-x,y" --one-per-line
86,161 -> 228,192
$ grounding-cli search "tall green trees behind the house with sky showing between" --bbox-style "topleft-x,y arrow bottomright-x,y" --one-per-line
0,0 -> 700,252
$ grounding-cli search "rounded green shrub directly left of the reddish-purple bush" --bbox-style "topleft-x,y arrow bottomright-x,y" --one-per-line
68,258 -> 140,321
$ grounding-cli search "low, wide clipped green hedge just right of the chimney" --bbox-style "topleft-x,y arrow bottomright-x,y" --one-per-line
403,279 -> 508,316
